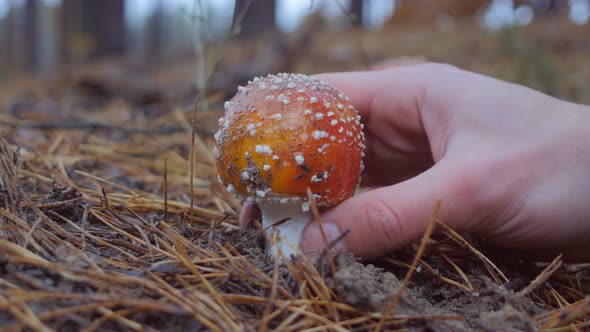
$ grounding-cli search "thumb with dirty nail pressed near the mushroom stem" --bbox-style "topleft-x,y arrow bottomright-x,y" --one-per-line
301,162 -> 474,258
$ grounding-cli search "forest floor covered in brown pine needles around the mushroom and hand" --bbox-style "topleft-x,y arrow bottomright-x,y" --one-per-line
0,17 -> 590,331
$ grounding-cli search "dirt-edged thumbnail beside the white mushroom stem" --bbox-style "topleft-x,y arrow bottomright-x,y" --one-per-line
301,223 -> 348,256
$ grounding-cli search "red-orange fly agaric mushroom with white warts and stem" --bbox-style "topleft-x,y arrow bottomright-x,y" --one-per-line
215,74 -> 365,257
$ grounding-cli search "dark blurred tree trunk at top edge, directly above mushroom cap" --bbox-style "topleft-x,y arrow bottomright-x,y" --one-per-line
233,0 -> 276,37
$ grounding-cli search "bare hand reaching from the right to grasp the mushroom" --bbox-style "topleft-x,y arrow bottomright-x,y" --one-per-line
302,64 -> 590,259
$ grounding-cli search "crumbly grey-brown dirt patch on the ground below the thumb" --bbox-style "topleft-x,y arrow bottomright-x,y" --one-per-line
336,255 -> 544,331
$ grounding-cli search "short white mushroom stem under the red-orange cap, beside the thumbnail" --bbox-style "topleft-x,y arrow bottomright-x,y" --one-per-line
258,201 -> 312,258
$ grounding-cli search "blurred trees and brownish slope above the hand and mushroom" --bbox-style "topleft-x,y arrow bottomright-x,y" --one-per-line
0,0 -> 590,101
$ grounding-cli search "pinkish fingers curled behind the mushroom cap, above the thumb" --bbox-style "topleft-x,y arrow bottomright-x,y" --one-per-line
317,64 -> 446,186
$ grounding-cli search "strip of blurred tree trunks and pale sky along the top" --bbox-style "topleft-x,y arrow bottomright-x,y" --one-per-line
0,0 -> 590,72
